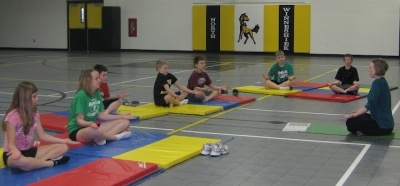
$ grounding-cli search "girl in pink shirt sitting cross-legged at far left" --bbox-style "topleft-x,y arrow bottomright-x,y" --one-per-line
2,82 -> 79,171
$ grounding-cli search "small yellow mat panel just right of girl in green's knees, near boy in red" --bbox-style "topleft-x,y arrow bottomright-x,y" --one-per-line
117,105 -> 168,119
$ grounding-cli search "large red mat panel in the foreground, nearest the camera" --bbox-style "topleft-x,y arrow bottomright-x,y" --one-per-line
30,158 -> 158,186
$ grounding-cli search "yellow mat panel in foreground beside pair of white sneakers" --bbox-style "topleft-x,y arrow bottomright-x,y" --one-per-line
113,136 -> 220,169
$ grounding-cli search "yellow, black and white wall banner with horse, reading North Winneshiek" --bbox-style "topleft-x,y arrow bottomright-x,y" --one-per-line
192,4 -> 311,54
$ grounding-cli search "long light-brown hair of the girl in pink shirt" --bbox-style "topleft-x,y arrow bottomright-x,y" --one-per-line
2,81 -> 38,135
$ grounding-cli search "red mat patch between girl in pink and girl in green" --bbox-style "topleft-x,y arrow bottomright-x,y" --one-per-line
40,114 -> 68,132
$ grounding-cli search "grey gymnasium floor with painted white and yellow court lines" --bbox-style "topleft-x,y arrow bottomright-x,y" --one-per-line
0,50 -> 400,186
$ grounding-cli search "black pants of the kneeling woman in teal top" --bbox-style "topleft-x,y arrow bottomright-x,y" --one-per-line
346,113 -> 393,136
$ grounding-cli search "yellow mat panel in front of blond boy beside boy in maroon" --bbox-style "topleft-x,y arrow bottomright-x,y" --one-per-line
141,103 -> 224,116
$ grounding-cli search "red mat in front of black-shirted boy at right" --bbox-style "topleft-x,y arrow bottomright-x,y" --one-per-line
286,91 -> 367,103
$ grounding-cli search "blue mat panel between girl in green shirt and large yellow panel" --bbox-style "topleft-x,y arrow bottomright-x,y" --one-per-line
69,131 -> 168,158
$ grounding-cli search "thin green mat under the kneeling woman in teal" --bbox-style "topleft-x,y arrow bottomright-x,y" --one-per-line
306,123 -> 400,139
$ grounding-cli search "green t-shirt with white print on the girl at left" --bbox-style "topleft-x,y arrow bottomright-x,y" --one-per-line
67,90 -> 104,133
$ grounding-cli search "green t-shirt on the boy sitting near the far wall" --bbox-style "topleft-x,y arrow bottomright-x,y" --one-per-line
268,62 -> 294,83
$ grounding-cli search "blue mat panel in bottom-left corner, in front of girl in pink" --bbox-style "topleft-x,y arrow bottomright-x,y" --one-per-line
0,153 -> 99,186
